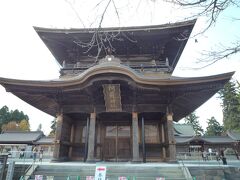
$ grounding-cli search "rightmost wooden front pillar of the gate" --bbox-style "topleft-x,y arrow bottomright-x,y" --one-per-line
166,108 -> 176,161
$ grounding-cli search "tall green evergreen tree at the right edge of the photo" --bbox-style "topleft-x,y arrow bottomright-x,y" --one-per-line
219,81 -> 240,132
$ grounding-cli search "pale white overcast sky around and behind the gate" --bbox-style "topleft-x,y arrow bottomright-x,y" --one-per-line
0,0 -> 240,134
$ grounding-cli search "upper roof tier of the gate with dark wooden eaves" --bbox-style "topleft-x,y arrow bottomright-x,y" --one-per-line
34,20 -> 196,72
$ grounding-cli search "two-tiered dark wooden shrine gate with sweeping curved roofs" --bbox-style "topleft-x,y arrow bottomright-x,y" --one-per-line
0,20 -> 233,162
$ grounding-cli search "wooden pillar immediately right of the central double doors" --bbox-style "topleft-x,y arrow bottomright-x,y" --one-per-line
132,112 -> 140,162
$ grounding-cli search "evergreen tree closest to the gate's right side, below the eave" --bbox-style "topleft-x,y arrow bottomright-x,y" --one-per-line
184,112 -> 203,136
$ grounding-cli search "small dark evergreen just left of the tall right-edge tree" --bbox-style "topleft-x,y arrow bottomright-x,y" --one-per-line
205,117 -> 223,136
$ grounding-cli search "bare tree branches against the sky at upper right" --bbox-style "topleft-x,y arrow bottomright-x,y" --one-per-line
161,0 -> 240,65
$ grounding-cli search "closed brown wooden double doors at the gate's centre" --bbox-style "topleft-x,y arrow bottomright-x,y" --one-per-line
103,123 -> 132,161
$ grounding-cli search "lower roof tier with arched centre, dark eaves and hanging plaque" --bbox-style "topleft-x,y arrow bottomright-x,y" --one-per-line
0,64 -> 233,121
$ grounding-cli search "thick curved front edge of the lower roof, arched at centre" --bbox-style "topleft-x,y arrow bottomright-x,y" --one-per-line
0,62 -> 234,87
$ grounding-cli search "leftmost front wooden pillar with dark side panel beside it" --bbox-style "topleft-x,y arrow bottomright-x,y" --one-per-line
52,113 -> 71,161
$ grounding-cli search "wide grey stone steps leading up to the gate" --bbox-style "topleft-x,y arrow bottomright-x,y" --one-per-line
31,165 -> 185,180
